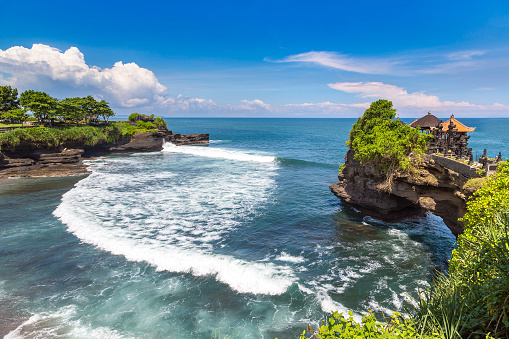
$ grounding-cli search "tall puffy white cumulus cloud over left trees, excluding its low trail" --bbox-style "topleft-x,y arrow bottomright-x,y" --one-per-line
0,44 -> 170,107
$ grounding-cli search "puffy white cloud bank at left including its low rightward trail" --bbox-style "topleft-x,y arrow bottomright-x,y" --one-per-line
0,44 -> 282,114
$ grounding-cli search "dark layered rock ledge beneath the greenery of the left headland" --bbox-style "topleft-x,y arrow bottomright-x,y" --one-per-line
0,130 -> 209,177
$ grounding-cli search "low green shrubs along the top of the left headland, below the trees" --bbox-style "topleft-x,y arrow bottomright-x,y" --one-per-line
0,122 -> 145,149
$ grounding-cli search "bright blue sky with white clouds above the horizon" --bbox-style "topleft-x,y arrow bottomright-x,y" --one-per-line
0,0 -> 509,118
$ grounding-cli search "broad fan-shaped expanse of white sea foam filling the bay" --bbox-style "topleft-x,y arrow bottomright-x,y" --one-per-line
54,146 -> 295,295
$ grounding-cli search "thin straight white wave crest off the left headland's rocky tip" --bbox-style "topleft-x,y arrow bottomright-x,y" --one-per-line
163,142 -> 276,163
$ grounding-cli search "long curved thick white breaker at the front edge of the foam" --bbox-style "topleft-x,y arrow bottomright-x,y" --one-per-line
54,201 -> 294,295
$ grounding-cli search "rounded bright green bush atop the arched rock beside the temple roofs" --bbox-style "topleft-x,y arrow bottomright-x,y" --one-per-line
347,100 -> 429,174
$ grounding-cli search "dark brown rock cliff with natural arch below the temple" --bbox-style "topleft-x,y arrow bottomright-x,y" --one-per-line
330,150 -> 474,235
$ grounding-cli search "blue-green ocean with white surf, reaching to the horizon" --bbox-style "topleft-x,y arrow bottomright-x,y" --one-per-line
0,118 -> 509,338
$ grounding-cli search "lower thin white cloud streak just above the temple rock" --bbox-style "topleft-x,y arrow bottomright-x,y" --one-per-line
329,82 -> 509,111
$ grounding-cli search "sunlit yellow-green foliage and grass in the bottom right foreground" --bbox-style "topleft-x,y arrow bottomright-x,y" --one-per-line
301,162 -> 509,339
